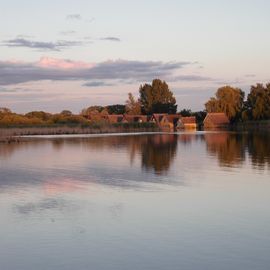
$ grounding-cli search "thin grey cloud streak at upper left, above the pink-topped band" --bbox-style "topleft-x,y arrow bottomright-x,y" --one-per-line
2,38 -> 82,51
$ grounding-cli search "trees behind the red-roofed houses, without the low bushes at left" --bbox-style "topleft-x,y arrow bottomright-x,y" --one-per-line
84,79 -> 270,123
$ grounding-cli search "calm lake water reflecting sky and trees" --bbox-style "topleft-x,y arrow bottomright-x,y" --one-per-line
0,132 -> 270,270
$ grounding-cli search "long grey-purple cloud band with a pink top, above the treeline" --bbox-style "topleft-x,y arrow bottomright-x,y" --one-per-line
0,58 -> 191,85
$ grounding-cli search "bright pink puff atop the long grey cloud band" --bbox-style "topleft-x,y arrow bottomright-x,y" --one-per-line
37,57 -> 94,69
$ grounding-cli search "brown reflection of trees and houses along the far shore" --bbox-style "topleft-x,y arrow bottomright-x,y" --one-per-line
0,131 -> 270,175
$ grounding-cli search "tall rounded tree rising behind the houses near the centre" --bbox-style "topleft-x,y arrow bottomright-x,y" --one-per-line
139,79 -> 177,114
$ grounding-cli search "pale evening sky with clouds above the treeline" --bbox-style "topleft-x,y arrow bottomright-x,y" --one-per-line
0,0 -> 270,113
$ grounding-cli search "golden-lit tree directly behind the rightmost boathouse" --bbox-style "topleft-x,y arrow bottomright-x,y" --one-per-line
205,86 -> 245,120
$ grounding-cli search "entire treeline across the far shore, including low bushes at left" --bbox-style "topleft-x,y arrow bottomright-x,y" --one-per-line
0,79 -> 270,127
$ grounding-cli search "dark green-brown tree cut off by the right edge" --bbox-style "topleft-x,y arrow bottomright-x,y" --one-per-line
242,83 -> 270,120
